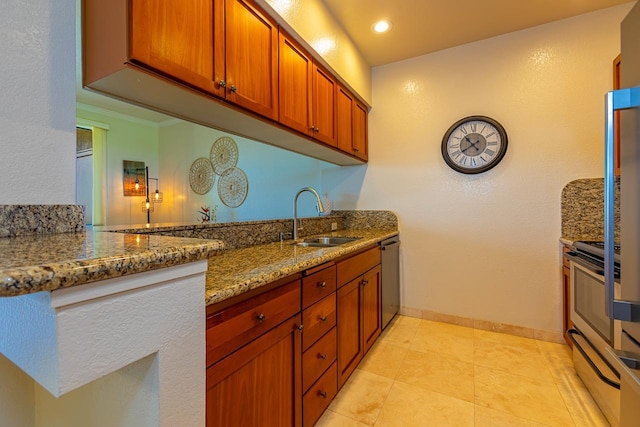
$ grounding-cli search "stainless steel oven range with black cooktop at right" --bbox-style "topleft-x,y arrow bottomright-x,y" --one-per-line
567,242 -> 622,427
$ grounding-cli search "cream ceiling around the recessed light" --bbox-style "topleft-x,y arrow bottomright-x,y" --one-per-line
322,0 -> 629,66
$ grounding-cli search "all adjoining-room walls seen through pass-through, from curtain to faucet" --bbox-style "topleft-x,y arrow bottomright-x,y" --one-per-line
77,105 -> 328,225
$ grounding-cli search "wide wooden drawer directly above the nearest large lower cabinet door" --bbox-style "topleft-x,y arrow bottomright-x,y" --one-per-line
206,280 -> 300,366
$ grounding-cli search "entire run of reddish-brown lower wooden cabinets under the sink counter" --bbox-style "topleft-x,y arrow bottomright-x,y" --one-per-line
206,246 -> 381,427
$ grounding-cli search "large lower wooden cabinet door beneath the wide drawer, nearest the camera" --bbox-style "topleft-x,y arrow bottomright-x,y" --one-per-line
206,315 -> 302,427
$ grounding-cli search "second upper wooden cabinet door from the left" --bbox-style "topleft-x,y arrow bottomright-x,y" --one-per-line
225,0 -> 278,119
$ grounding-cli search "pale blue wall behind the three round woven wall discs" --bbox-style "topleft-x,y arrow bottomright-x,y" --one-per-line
152,118 -> 327,222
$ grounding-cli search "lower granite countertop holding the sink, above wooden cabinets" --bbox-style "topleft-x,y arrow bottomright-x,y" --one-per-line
205,229 -> 398,305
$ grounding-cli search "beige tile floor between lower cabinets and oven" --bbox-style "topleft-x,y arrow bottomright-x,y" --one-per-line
316,316 -> 609,427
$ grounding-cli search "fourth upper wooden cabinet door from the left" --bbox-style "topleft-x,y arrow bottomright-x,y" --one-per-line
313,64 -> 336,147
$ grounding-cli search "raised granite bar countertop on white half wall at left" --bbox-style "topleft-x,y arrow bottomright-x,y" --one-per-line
0,228 -> 224,297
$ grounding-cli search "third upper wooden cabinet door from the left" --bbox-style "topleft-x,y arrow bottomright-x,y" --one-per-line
278,31 -> 313,136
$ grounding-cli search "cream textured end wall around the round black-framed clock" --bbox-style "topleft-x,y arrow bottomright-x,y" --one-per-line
323,4 -> 630,332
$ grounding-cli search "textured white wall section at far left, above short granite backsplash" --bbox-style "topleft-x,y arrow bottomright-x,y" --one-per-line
0,0 -> 75,204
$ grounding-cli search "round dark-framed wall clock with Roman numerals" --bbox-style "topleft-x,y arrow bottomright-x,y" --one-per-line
442,116 -> 507,174
